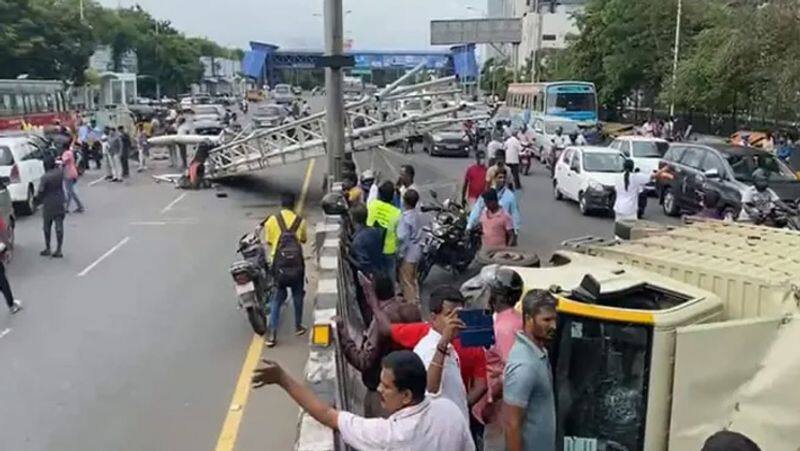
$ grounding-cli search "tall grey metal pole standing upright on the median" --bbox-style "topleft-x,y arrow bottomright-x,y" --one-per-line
324,0 -> 344,181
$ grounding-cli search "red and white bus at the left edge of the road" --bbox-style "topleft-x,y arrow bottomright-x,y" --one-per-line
0,80 -> 74,130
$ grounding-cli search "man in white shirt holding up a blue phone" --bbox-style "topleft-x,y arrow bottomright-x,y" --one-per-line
414,285 -> 469,421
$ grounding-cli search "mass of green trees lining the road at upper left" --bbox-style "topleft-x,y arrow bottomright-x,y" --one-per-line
0,0 -> 241,95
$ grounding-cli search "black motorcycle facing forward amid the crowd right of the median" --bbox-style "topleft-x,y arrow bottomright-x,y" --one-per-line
417,191 -> 481,284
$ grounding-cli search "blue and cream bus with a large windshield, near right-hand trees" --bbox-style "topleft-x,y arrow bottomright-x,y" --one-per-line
506,81 -> 598,127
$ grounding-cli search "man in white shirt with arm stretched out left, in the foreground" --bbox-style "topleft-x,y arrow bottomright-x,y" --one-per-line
253,351 -> 475,451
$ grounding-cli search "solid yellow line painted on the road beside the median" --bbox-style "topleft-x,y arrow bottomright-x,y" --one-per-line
215,160 -> 315,451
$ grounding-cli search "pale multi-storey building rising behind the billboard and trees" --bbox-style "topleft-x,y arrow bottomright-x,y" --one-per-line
486,0 -> 588,67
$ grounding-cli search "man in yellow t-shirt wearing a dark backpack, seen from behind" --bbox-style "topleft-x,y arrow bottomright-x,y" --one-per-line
264,193 -> 307,348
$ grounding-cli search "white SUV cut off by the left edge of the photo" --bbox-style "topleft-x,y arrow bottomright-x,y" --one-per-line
0,136 -> 44,215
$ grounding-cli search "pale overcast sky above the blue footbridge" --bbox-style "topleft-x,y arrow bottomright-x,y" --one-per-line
95,0 -> 486,50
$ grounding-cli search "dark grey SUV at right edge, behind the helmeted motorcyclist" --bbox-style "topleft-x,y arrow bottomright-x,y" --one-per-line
656,143 -> 800,218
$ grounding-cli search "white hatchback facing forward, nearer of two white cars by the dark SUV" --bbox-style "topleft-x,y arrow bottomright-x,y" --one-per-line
553,146 -> 625,215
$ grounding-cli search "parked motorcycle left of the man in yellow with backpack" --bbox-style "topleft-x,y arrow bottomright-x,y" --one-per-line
230,227 -> 274,335
